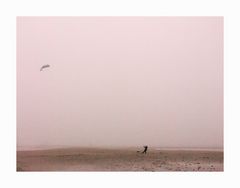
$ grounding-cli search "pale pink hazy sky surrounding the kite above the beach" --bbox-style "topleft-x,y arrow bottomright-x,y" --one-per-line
17,17 -> 223,148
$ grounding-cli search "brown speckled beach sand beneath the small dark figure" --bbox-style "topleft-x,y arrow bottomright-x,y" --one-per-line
17,148 -> 223,171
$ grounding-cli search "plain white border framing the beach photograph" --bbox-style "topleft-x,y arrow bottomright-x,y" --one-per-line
0,0 -> 240,188
